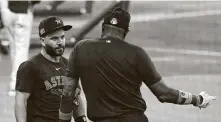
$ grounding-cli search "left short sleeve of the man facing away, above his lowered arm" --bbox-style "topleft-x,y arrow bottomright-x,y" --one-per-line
66,45 -> 79,78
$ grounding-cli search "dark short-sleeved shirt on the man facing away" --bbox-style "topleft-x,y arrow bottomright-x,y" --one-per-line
67,38 -> 161,121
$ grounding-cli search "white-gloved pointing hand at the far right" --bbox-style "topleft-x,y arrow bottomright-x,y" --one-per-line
196,91 -> 217,109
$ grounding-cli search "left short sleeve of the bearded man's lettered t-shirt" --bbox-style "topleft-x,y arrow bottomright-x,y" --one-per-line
15,61 -> 37,93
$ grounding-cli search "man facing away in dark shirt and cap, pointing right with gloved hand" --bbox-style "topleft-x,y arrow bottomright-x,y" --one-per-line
59,8 -> 216,122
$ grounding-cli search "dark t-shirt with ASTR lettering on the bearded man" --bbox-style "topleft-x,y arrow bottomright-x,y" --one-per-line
16,54 -> 70,122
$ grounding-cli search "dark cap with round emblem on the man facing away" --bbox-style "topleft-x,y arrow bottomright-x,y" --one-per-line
103,7 -> 130,30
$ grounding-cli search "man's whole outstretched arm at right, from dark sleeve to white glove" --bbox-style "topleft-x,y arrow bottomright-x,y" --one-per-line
136,48 -> 216,108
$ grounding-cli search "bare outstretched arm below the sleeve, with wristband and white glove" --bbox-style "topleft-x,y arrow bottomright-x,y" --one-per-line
148,80 -> 216,108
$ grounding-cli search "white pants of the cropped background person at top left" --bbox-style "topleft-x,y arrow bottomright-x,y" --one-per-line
2,8 -> 33,90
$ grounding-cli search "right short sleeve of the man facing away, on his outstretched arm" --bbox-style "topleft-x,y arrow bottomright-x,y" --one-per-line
136,47 -> 162,86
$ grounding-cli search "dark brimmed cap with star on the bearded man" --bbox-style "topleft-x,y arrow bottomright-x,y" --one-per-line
38,16 -> 72,37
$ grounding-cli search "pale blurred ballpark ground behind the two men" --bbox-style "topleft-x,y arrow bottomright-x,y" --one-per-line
0,1 -> 221,122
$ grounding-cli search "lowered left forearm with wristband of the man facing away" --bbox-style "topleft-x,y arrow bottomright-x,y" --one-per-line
59,77 -> 78,120
